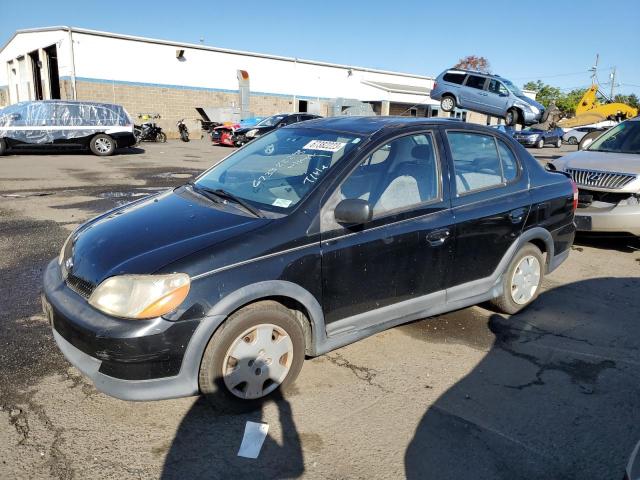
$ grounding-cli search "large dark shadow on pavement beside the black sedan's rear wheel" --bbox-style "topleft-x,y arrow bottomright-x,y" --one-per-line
405,278 -> 640,480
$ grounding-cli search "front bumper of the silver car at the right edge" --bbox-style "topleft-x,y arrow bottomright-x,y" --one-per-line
575,202 -> 640,236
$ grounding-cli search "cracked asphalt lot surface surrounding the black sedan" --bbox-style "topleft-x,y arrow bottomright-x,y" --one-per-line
0,137 -> 640,480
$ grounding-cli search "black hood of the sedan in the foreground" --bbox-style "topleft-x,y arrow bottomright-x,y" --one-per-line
65,187 -> 270,284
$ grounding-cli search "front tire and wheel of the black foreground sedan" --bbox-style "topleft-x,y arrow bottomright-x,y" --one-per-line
199,300 -> 305,411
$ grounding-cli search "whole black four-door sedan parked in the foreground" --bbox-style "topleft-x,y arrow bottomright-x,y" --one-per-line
43,117 -> 577,406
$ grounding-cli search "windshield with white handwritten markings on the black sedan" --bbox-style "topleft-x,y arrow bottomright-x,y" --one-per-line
195,128 -> 362,213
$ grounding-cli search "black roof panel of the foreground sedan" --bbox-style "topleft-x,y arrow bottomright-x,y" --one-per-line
285,116 -> 480,135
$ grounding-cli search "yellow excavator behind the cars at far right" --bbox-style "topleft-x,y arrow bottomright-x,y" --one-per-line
556,80 -> 638,128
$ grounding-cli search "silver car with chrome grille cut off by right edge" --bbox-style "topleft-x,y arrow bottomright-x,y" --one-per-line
549,117 -> 640,236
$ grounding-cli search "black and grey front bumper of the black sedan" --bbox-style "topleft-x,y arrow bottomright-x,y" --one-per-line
43,260 -> 222,400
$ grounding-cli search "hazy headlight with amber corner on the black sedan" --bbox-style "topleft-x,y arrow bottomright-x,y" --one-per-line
89,273 -> 191,319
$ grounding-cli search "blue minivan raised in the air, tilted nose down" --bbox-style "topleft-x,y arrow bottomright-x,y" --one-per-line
431,68 -> 546,126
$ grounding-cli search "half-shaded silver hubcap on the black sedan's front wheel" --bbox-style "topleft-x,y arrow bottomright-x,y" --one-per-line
222,324 -> 293,400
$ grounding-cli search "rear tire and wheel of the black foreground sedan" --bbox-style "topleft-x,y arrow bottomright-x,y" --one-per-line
489,243 -> 545,315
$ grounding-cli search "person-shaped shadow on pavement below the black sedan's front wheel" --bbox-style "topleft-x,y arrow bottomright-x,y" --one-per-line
161,378 -> 304,480
